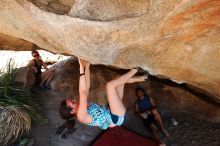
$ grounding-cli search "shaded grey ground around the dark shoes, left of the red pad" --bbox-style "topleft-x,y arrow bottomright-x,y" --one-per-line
30,90 -> 101,146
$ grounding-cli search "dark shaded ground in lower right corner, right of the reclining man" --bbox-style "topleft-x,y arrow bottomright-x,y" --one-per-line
164,113 -> 220,146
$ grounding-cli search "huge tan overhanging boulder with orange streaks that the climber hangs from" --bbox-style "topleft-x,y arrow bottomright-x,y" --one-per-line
0,0 -> 220,103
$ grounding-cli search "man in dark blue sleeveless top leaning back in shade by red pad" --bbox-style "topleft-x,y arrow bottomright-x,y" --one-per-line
135,88 -> 170,146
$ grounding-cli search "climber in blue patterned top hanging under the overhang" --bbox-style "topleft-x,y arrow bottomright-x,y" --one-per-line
59,59 -> 147,129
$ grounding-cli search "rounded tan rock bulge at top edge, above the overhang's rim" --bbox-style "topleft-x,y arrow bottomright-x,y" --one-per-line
68,0 -> 150,21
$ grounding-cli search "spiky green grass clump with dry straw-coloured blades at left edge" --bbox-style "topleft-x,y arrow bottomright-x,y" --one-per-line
0,60 -> 45,145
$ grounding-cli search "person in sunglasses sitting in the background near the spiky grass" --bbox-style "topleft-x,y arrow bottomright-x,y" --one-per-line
27,50 -> 54,89
